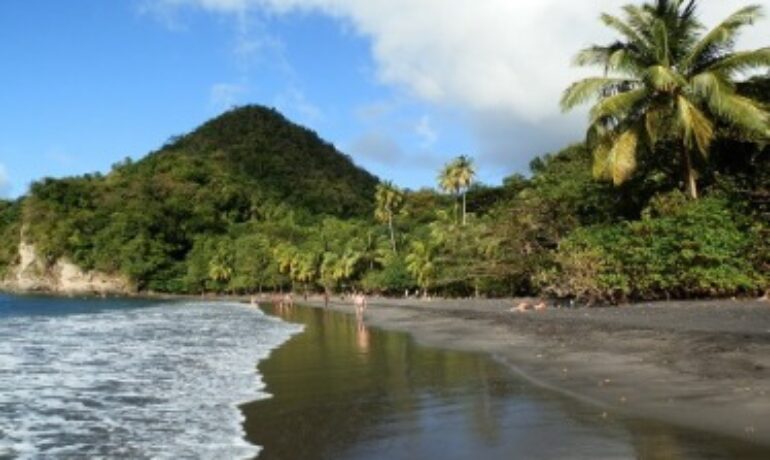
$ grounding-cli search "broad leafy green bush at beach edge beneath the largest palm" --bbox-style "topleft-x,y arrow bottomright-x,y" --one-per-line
539,192 -> 767,303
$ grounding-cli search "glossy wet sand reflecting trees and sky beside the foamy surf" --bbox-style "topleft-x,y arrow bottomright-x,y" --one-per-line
243,307 -> 769,459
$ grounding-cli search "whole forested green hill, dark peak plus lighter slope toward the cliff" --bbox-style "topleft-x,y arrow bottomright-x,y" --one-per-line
8,106 -> 378,290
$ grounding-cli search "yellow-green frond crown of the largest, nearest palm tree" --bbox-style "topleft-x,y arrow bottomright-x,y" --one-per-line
561,0 -> 770,198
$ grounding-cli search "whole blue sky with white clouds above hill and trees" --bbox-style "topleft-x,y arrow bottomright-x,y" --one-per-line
0,0 -> 770,197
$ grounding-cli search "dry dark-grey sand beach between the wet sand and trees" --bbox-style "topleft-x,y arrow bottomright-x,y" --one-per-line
294,298 -> 770,446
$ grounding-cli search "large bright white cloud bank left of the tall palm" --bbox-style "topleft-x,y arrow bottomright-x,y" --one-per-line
147,0 -> 770,181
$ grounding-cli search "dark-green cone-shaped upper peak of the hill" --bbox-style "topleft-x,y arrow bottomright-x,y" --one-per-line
144,106 -> 378,217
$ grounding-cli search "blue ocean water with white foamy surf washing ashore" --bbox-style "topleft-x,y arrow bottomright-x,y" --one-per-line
0,295 -> 302,459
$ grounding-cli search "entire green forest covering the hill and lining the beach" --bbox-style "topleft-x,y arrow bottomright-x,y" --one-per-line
0,0 -> 770,303
